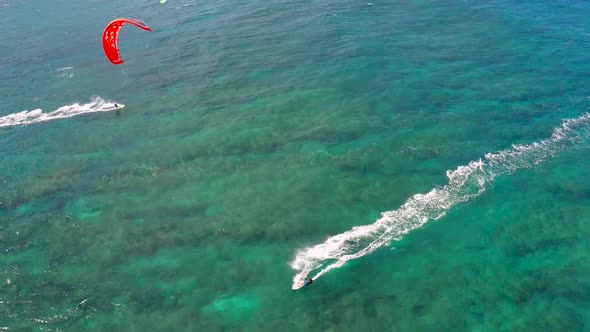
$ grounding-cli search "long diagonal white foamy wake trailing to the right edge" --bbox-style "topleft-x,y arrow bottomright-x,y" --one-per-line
291,113 -> 590,289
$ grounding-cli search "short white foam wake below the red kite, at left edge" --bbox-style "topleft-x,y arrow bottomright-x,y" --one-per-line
0,97 -> 116,128
